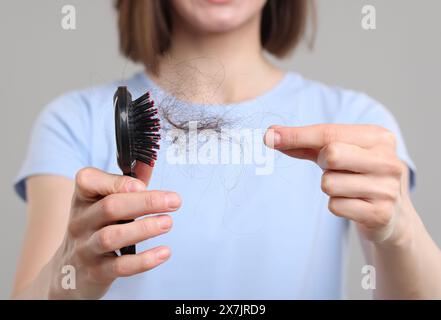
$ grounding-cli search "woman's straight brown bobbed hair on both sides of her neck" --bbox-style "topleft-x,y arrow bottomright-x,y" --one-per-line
115,0 -> 315,73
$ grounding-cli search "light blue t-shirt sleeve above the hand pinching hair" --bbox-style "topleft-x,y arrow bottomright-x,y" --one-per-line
336,94 -> 416,190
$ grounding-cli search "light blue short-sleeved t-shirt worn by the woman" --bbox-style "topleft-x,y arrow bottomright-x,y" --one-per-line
15,73 -> 414,299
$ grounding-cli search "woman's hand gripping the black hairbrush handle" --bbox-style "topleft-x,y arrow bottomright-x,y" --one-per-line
48,168 -> 181,299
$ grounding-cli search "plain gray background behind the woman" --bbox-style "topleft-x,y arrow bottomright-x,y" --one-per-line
0,0 -> 441,298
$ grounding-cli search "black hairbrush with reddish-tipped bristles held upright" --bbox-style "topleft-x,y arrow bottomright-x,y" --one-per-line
113,87 -> 160,255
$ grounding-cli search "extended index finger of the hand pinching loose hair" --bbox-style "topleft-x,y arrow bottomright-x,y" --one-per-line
265,124 -> 381,151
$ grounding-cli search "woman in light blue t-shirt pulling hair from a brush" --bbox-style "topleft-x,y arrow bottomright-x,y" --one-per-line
13,0 -> 441,299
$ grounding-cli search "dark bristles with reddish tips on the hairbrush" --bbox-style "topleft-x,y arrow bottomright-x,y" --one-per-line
129,92 -> 161,167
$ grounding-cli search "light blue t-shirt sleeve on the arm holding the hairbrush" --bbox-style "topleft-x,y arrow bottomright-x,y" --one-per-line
14,93 -> 90,201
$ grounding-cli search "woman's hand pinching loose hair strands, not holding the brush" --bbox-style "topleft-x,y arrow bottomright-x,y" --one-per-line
265,124 -> 410,242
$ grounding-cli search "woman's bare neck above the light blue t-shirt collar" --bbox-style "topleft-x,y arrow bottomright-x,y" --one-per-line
152,10 -> 283,104
